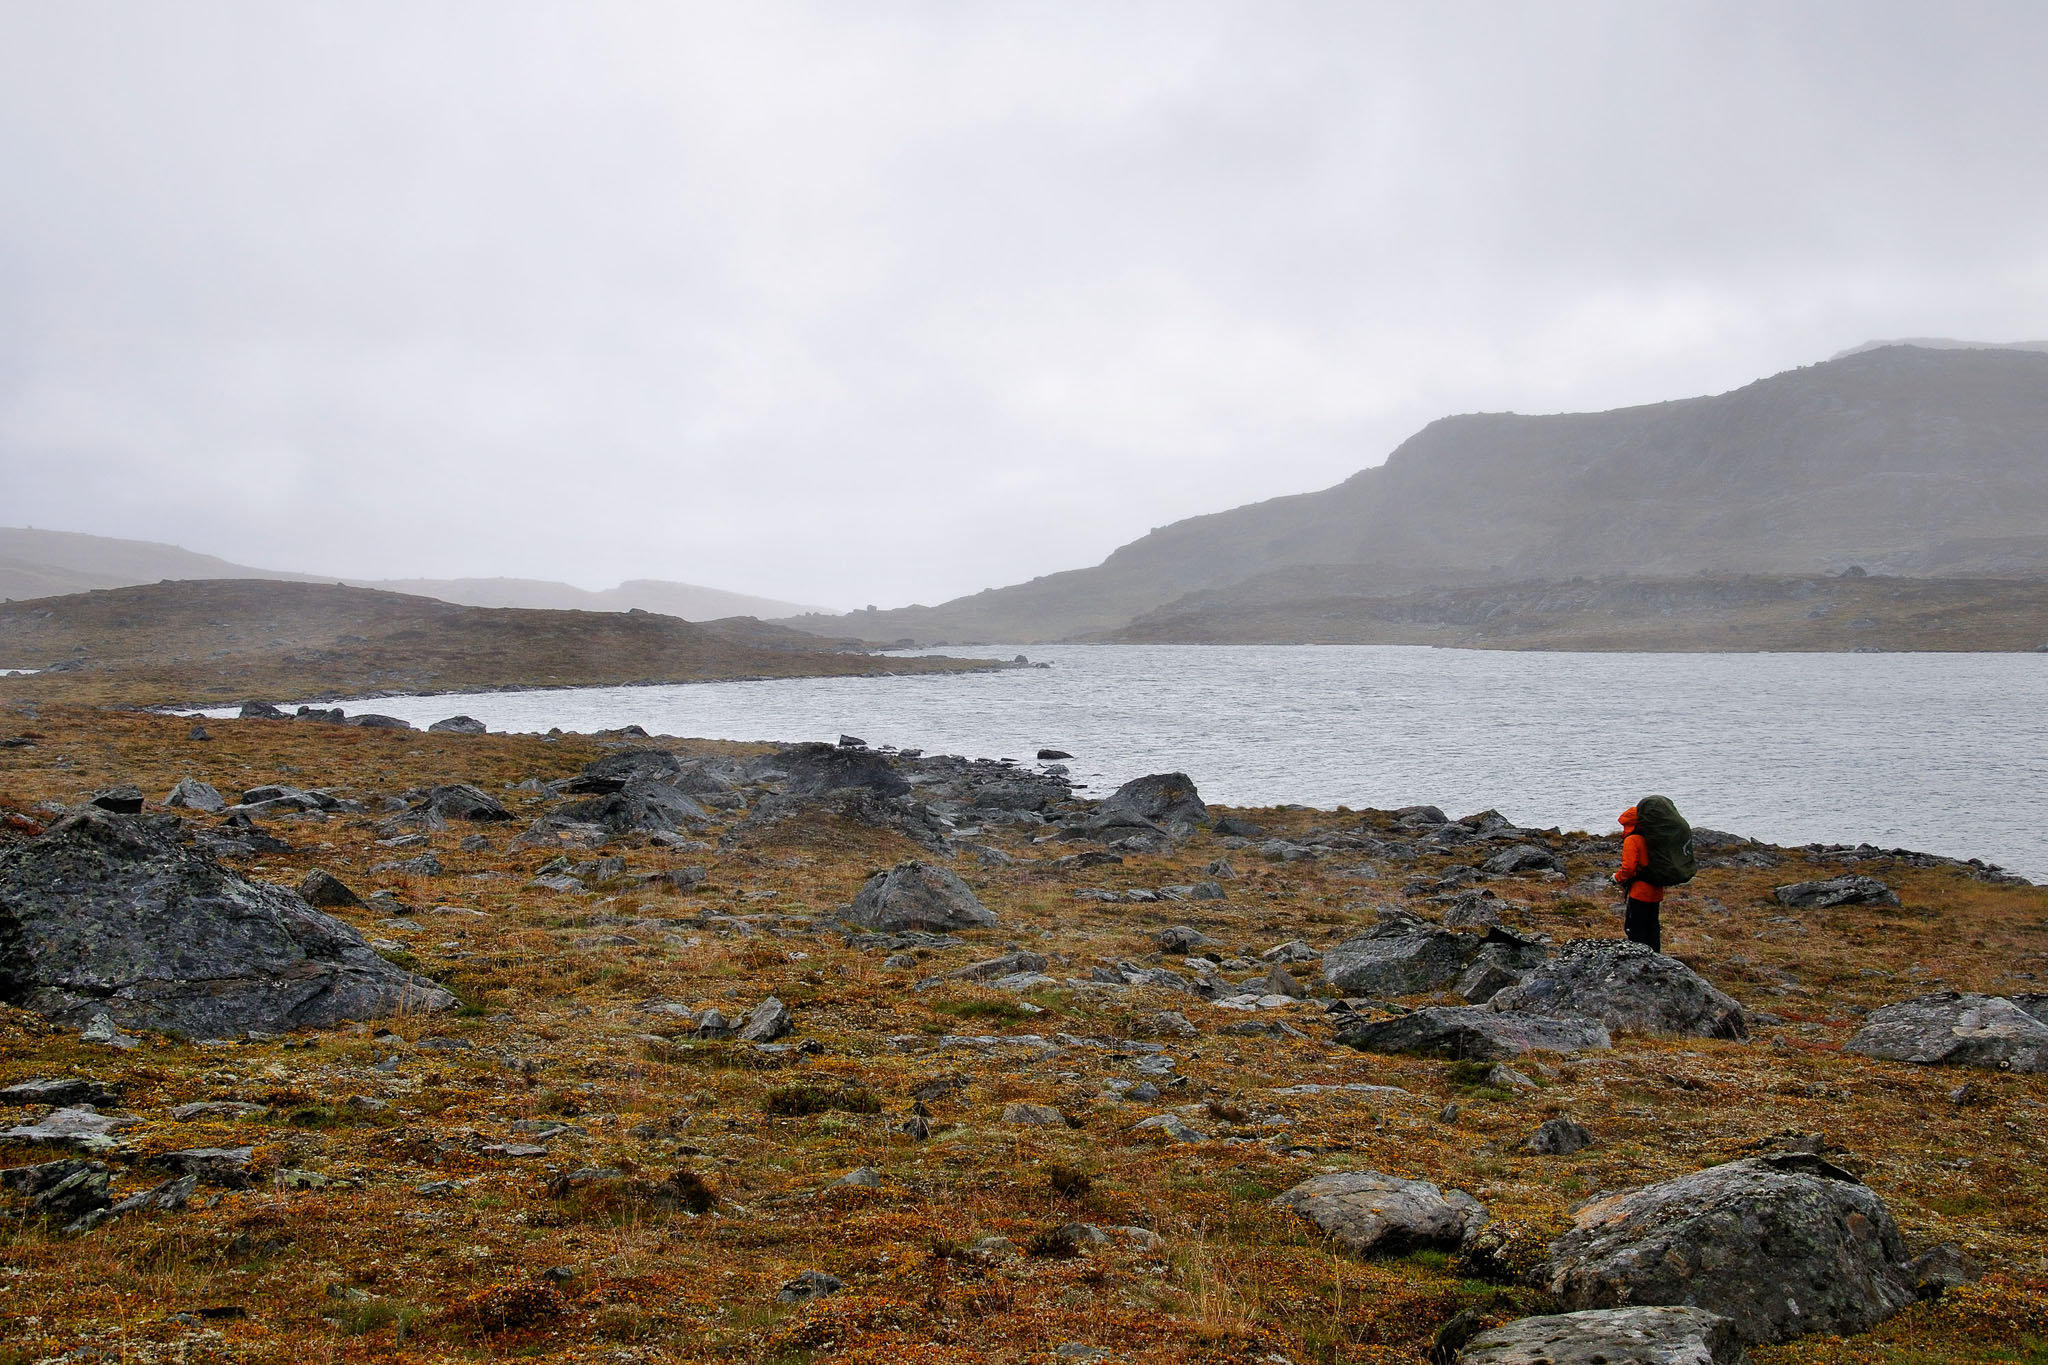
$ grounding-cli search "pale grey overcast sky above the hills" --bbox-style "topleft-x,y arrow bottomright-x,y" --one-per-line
0,0 -> 2048,606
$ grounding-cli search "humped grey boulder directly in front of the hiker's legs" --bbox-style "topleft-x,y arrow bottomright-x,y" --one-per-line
1487,939 -> 1749,1038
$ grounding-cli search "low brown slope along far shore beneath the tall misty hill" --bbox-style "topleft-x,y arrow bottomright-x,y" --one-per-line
1102,575 -> 2048,651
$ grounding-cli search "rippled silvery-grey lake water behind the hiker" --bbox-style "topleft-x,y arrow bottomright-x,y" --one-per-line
228,645 -> 2048,880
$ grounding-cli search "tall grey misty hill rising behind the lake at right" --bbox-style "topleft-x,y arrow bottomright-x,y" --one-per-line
791,346 -> 2048,643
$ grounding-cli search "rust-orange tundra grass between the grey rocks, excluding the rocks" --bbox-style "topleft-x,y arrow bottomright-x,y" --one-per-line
0,706 -> 2048,1365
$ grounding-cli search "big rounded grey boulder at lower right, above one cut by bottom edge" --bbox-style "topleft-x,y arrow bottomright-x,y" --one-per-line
1542,1154 -> 1915,1345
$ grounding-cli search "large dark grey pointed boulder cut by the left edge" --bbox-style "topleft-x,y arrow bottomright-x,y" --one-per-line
0,810 -> 457,1038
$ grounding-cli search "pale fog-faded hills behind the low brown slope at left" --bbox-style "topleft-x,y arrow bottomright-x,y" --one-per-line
0,526 -> 825,620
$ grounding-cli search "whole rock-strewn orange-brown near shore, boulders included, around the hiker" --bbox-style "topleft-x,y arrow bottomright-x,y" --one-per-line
0,706 -> 2048,1365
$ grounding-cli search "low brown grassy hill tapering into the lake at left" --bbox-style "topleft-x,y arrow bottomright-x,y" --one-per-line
0,579 -> 989,704
